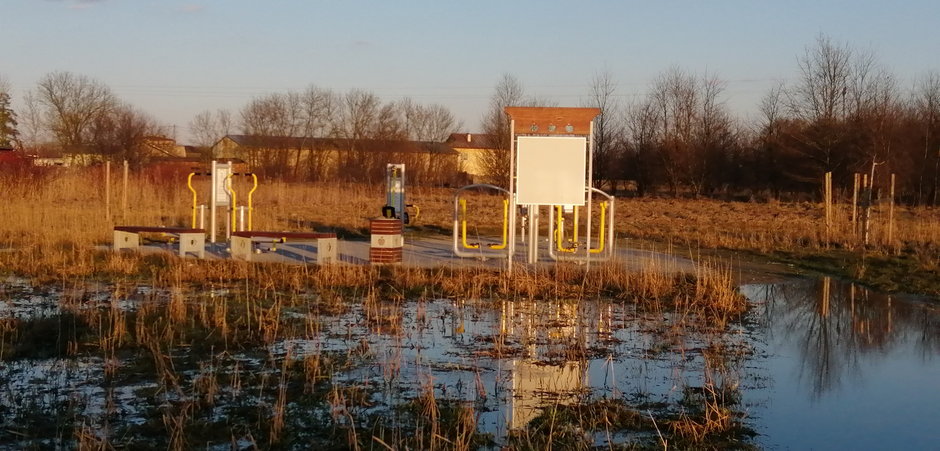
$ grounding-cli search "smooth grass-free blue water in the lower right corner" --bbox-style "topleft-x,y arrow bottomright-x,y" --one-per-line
742,281 -> 940,449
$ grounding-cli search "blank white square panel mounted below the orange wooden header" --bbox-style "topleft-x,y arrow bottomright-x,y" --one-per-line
516,136 -> 587,205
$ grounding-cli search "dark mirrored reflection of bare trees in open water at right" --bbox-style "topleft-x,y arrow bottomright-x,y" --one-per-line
742,277 -> 940,398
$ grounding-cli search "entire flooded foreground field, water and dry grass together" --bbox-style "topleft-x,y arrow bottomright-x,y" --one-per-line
0,279 -> 940,449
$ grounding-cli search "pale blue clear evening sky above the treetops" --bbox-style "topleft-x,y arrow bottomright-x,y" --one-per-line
0,0 -> 940,142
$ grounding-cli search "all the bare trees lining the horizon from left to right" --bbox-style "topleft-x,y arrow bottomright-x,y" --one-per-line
7,35 -> 940,205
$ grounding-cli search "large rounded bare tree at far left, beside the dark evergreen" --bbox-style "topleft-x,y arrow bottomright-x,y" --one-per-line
35,72 -> 117,153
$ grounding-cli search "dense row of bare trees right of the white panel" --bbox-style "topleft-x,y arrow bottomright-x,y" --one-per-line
556,36 -> 940,205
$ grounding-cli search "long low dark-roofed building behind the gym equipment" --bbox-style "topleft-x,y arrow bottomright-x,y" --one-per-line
211,135 -> 459,185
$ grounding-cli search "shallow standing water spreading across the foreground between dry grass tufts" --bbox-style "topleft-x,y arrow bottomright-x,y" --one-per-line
0,279 -> 940,449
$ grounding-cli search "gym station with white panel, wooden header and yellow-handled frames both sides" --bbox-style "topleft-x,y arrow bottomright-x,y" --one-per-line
454,107 -> 614,271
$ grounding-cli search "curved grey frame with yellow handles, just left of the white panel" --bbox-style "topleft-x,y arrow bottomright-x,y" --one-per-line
453,184 -> 511,259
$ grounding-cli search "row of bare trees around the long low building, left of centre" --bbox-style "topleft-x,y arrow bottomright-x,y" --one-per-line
196,86 -> 460,180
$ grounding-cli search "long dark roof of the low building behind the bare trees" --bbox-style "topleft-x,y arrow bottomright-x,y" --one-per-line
223,135 -> 457,154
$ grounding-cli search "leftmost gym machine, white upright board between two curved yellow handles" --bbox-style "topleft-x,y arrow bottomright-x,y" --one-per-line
186,161 -> 258,243
